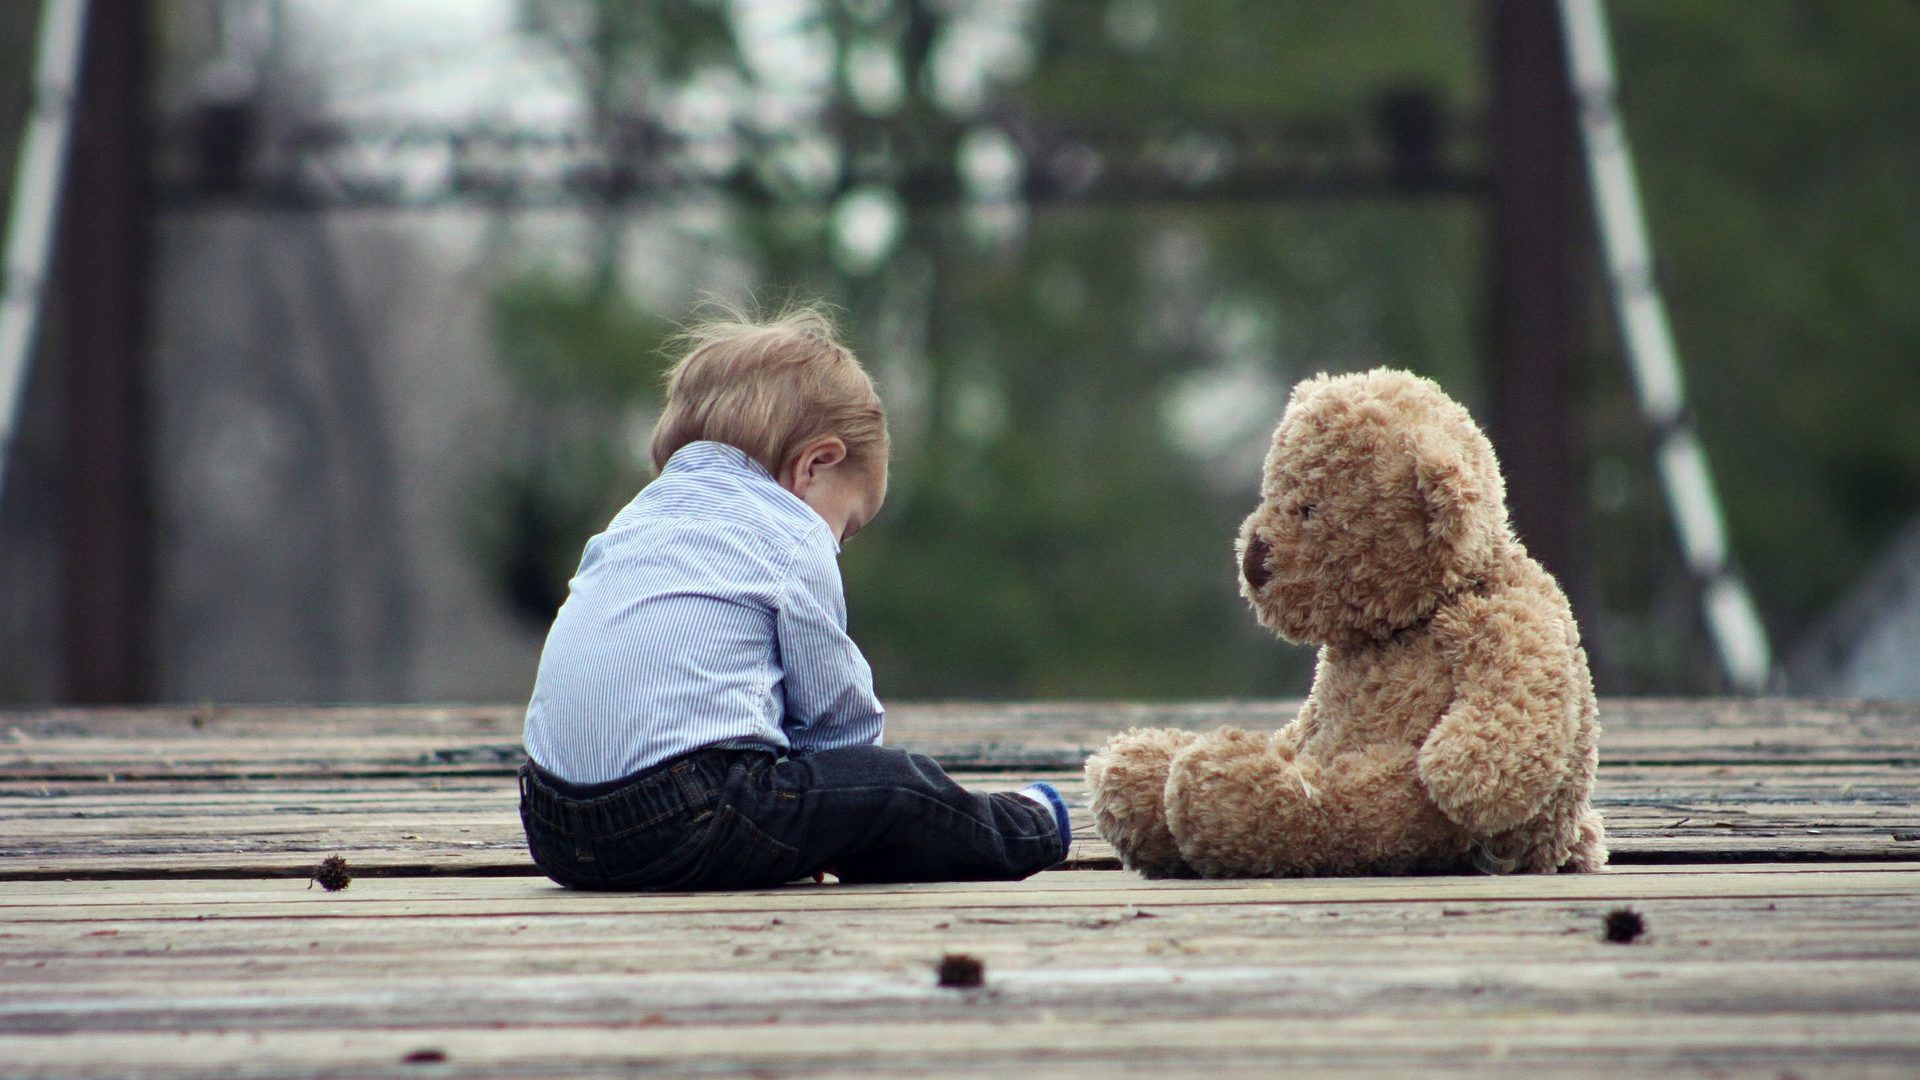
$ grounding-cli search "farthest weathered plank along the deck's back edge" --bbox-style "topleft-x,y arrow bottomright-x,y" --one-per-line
0,700 -> 1920,780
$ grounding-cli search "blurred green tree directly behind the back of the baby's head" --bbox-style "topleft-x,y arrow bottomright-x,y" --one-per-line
467,0 -> 730,626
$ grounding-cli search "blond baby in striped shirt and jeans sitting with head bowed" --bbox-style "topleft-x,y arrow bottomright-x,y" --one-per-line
520,309 -> 1071,890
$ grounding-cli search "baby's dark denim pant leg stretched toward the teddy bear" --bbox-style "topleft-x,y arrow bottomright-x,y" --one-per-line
751,746 -> 1062,882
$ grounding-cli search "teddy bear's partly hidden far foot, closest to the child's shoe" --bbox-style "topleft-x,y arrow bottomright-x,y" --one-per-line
1087,728 -> 1198,878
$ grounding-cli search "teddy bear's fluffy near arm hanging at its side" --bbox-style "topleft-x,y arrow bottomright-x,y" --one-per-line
1419,594 -> 1578,838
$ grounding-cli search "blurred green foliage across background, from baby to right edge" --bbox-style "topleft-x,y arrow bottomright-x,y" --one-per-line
476,0 -> 1920,698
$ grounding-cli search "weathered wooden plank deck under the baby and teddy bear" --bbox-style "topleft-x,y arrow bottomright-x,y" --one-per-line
0,701 -> 1920,1076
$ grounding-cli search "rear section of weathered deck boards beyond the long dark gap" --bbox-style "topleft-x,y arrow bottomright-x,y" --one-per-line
0,701 -> 1920,880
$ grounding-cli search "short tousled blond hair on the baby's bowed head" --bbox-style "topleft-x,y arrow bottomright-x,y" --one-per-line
653,306 -> 891,477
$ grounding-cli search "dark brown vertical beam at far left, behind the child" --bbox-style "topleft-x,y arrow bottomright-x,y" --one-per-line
52,0 -> 154,703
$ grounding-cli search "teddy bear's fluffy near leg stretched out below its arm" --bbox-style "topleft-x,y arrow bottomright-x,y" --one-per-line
1167,730 -> 1467,878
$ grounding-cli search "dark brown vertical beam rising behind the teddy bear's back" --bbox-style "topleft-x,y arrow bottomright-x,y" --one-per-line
1488,0 -> 1590,607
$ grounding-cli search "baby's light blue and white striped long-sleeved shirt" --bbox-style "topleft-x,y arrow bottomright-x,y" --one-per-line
526,442 -> 883,784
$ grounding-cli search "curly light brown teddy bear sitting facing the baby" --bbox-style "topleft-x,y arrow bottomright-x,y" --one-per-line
1087,369 -> 1607,878
